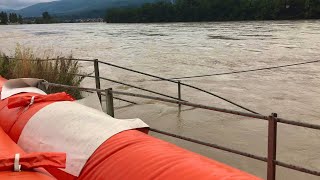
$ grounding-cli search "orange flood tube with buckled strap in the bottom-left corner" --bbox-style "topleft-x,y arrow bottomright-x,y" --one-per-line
0,127 -> 66,180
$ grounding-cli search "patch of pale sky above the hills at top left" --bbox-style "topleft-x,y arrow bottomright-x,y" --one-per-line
0,0 -> 54,9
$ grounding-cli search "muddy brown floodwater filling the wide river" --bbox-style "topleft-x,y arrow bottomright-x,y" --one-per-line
0,21 -> 320,180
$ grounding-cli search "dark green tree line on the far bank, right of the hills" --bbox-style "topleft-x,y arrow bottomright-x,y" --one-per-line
105,0 -> 320,23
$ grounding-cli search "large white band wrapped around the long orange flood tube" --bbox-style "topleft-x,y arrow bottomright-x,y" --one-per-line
18,102 -> 149,176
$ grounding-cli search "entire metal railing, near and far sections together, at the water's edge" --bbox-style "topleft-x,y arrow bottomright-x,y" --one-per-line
9,59 -> 320,180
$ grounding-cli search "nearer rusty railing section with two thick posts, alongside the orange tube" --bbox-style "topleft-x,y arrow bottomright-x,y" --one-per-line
43,82 -> 320,180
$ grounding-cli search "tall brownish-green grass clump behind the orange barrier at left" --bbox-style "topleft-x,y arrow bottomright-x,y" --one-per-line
0,45 -> 84,99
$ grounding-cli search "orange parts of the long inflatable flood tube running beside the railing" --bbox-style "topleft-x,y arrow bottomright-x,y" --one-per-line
0,78 -> 259,180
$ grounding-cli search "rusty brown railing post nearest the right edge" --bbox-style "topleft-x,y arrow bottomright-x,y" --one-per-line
267,113 -> 277,180
